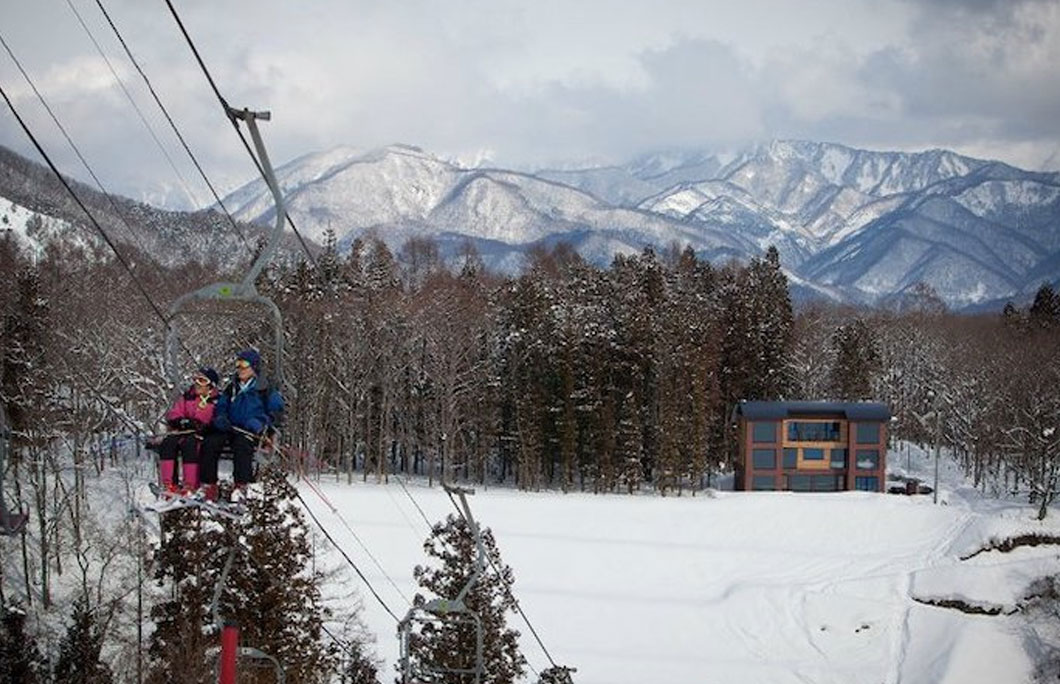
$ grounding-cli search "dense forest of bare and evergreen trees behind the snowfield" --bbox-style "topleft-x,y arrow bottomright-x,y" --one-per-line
0,225 -> 1060,682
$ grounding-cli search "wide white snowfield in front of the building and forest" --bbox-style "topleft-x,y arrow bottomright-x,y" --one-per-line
302,443 -> 1060,684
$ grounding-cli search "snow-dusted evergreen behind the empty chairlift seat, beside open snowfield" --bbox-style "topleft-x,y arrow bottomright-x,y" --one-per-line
409,515 -> 526,684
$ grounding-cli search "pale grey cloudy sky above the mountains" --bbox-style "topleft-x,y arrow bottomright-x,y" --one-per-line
0,0 -> 1060,205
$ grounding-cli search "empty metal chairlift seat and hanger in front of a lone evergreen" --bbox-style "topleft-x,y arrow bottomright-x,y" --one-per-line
398,483 -> 485,684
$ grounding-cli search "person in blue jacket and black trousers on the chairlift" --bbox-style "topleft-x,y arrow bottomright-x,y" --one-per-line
199,349 -> 284,501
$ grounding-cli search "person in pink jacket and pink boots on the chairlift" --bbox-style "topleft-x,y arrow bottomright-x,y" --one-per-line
158,367 -> 220,494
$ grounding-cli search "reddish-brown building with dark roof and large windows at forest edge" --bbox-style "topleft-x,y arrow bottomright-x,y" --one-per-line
735,401 -> 890,492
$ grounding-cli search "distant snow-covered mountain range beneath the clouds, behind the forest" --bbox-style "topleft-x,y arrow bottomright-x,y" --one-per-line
225,141 -> 1060,308
